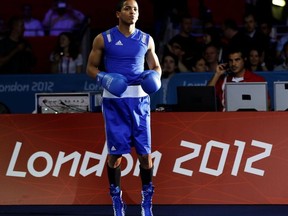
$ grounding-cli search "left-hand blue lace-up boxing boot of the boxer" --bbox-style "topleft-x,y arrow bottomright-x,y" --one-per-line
110,184 -> 125,216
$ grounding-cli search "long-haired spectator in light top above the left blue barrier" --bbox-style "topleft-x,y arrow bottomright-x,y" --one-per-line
50,32 -> 83,74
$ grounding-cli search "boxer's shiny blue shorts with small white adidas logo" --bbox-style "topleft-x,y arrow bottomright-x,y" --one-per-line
102,86 -> 151,155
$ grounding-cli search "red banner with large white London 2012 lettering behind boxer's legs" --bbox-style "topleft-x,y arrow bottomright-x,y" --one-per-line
0,112 -> 288,205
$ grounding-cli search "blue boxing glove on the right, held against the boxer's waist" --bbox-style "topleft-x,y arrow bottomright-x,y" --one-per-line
141,70 -> 161,94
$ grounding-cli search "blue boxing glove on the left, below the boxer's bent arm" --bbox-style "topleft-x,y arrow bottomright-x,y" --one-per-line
96,71 -> 128,97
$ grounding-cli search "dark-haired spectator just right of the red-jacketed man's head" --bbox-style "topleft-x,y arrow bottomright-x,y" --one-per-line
248,47 -> 268,71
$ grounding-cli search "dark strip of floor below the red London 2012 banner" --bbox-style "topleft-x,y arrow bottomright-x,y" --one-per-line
0,205 -> 288,216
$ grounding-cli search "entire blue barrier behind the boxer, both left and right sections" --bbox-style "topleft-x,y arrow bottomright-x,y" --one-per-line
0,71 -> 288,113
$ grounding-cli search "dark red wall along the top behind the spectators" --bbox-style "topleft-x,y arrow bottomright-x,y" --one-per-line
0,0 -> 245,29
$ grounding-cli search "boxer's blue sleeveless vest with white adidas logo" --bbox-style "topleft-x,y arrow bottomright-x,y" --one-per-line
102,26 -> 149,85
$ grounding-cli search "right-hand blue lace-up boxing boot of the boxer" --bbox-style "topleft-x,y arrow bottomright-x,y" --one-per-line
141,183 -> 154,216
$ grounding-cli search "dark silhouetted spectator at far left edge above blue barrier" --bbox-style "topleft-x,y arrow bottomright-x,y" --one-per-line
0,17 -> 36,74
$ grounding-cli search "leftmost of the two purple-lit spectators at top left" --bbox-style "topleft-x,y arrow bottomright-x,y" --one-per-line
22,4 -> 44,37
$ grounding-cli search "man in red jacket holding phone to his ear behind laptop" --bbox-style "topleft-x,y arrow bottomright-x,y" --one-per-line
207,47 -> 270,111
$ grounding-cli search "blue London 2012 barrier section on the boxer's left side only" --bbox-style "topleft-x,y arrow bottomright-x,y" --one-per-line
0,74 -> 99,114
